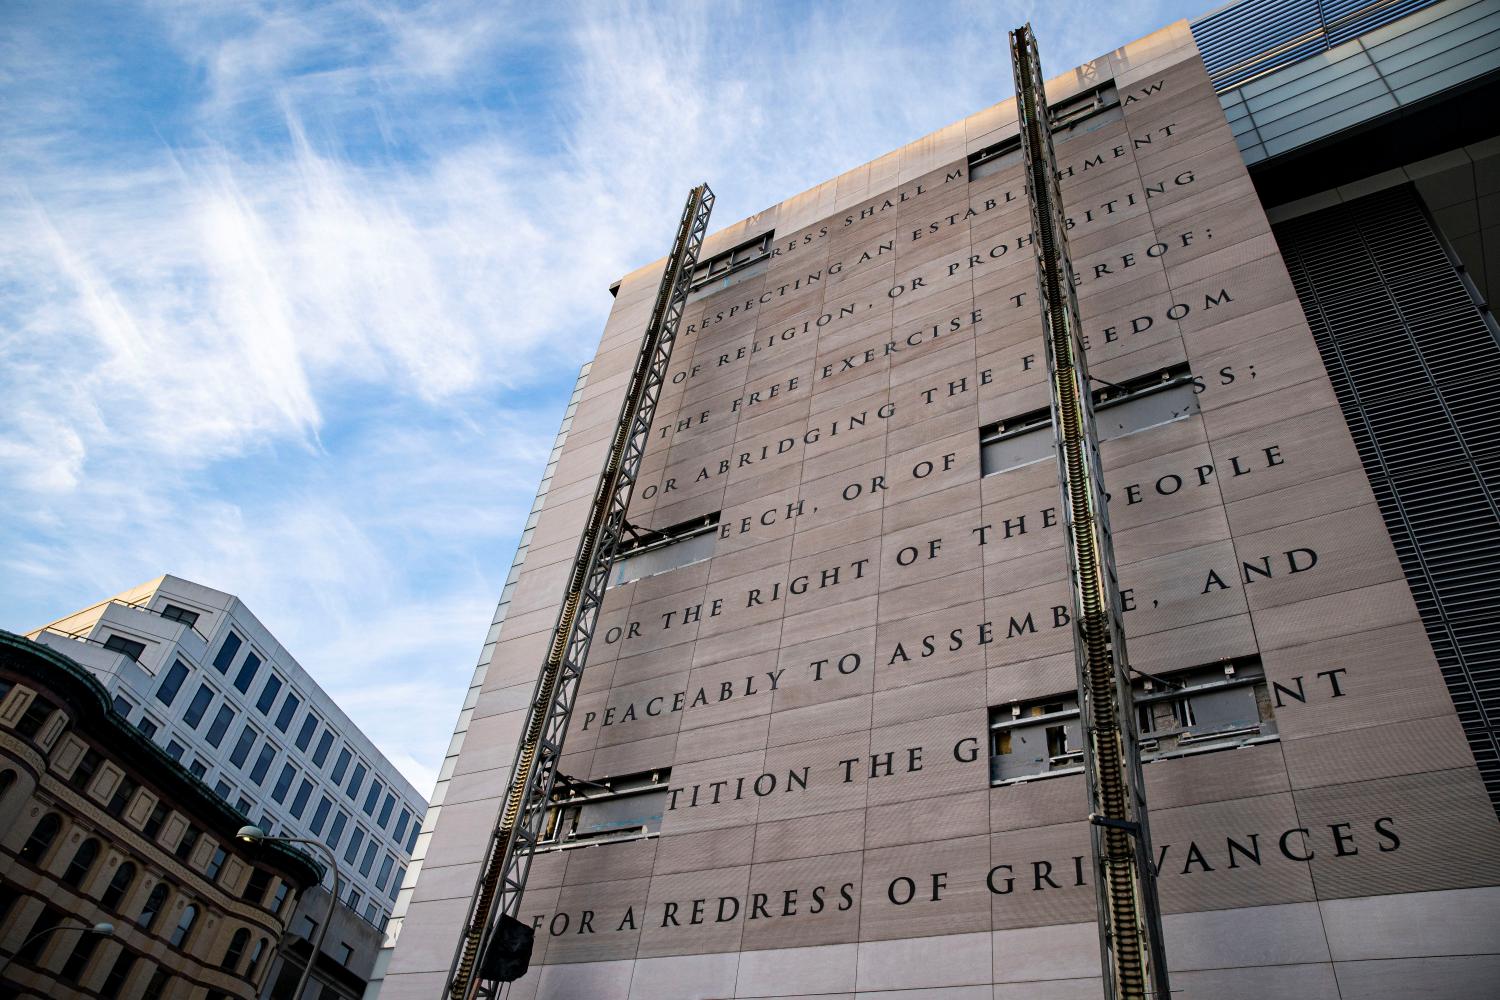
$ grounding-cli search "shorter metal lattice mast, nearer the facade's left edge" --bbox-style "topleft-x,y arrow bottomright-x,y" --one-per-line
443,184 -> 714,1000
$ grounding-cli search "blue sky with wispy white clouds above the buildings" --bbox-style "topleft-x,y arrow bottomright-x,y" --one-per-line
0,0 -> 1206,792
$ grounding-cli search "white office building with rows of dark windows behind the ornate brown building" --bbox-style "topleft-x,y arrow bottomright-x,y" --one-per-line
29,576 -> 426,930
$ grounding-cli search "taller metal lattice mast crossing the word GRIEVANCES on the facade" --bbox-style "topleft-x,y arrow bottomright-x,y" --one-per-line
1011,24 -> 1169,1000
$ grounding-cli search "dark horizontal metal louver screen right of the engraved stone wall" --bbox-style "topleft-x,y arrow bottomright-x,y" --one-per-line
1277,186 -> 1500,811
